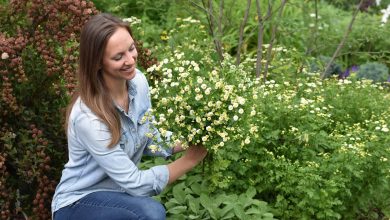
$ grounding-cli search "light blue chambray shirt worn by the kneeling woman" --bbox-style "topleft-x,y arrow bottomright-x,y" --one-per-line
52,70 -> 172,213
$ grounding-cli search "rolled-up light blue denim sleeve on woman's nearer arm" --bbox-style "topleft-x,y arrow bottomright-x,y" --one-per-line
74,113 -> 169,196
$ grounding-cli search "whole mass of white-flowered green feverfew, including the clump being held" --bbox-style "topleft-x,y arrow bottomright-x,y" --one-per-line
144,16 -> 390,219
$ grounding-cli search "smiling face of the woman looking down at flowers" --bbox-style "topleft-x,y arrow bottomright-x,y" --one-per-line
102,28 -> 138,83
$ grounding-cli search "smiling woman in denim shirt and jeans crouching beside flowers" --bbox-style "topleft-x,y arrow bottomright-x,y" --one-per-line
52,14 -> 207,220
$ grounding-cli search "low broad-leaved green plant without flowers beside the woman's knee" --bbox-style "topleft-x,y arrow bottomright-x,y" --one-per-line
142,159 -> 274,220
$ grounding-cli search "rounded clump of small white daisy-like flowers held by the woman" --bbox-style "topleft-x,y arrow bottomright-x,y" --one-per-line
147,19 -> 253,155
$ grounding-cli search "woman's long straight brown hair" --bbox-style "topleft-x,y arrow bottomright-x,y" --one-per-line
65,13 -> 133,147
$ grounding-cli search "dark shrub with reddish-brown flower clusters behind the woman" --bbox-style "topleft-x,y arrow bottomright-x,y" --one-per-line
0,0 -> 156,219
